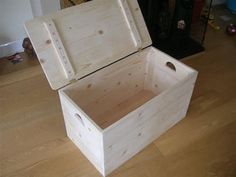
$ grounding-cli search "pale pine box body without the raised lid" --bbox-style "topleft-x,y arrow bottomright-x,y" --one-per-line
59,47 -> 197,176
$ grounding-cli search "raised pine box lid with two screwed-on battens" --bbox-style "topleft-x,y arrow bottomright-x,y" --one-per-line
25,0 -> 152,89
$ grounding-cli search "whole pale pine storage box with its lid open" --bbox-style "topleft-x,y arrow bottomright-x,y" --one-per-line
26,0 -> 197,176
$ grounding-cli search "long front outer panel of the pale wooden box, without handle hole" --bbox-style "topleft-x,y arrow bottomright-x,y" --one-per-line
103,73 -> 197,175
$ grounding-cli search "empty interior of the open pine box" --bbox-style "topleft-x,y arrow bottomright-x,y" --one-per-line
63,49 -> 192,129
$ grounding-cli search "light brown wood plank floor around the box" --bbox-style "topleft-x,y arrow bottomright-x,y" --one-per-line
0,11 -> 236,177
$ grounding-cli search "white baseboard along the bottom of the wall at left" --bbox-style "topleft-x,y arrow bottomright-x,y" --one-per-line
0,40 -> 24,58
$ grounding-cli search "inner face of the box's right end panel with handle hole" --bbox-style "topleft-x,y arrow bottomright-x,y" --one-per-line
145,47 -> 196,91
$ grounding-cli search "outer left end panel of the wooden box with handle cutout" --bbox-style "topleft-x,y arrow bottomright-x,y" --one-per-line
59,91 -> 104,174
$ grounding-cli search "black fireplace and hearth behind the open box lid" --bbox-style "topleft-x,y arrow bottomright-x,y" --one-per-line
138,0 -> 210,59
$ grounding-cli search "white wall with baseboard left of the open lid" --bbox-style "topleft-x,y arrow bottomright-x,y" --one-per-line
0,0 -> 60,57
